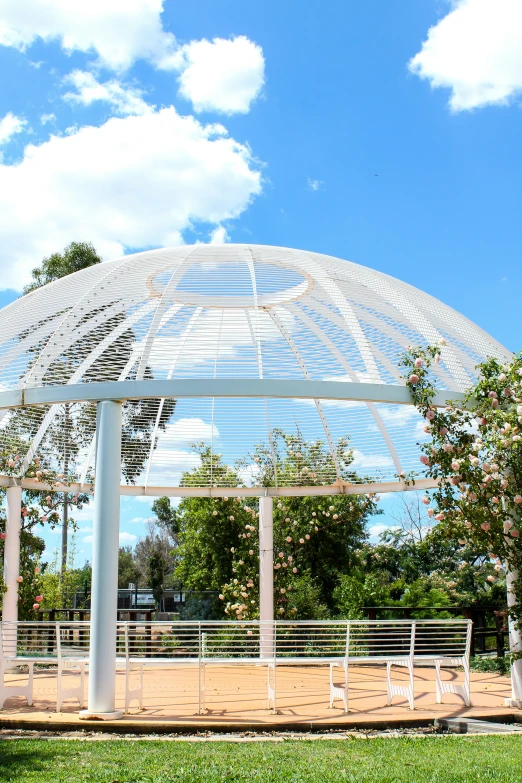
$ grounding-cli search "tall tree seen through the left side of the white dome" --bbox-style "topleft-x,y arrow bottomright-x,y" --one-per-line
13,242 -> 176,574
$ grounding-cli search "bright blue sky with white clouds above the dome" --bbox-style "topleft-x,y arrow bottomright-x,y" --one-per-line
0,0 -> 522,559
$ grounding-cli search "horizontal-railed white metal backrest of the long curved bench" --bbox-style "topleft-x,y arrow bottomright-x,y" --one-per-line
1,620 -> 470,665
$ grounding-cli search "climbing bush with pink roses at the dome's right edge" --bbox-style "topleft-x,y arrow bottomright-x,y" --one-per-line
400,341 -> 522,626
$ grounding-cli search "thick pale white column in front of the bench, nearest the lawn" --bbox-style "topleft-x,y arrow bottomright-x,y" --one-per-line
80,400 -> 123,720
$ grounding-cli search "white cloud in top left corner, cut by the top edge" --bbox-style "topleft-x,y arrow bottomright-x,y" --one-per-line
0,0 -> 175,70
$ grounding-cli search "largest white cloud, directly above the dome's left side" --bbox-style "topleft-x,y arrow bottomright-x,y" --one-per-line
0,107 -> 261,289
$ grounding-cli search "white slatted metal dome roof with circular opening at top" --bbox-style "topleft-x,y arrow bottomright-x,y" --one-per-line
0,245 -> 509,494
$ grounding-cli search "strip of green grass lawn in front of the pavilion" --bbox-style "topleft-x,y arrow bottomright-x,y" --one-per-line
0,736 -> 522,783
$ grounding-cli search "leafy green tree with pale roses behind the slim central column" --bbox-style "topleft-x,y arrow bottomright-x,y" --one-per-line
171,431 -> 379,619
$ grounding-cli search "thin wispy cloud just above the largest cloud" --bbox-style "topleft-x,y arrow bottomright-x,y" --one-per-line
63,70 -> 150,116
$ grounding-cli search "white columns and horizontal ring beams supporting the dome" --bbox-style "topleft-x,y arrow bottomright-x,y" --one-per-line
0,378 -> 463,720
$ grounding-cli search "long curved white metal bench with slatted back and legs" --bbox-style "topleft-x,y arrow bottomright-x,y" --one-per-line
0,620 -> 471,713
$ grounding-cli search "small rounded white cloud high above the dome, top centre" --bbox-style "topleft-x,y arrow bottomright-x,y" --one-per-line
177,35 -> 265,114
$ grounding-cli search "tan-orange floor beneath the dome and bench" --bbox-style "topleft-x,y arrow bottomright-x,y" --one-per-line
0,666 -> 513,730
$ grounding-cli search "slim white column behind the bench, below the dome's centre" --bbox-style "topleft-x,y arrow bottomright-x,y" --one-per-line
259,496 -> 274,658
